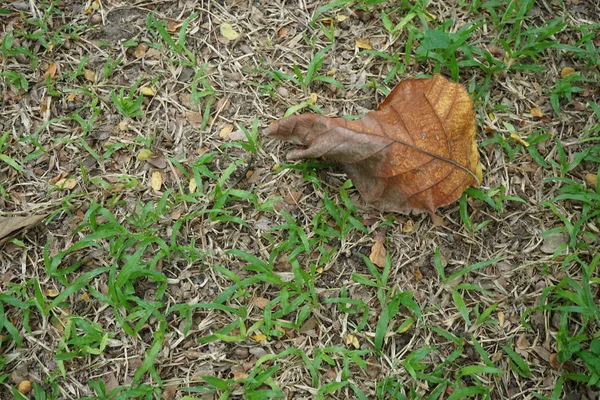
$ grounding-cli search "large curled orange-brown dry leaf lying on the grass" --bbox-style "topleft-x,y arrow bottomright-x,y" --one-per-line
266,75 -> 482,212
